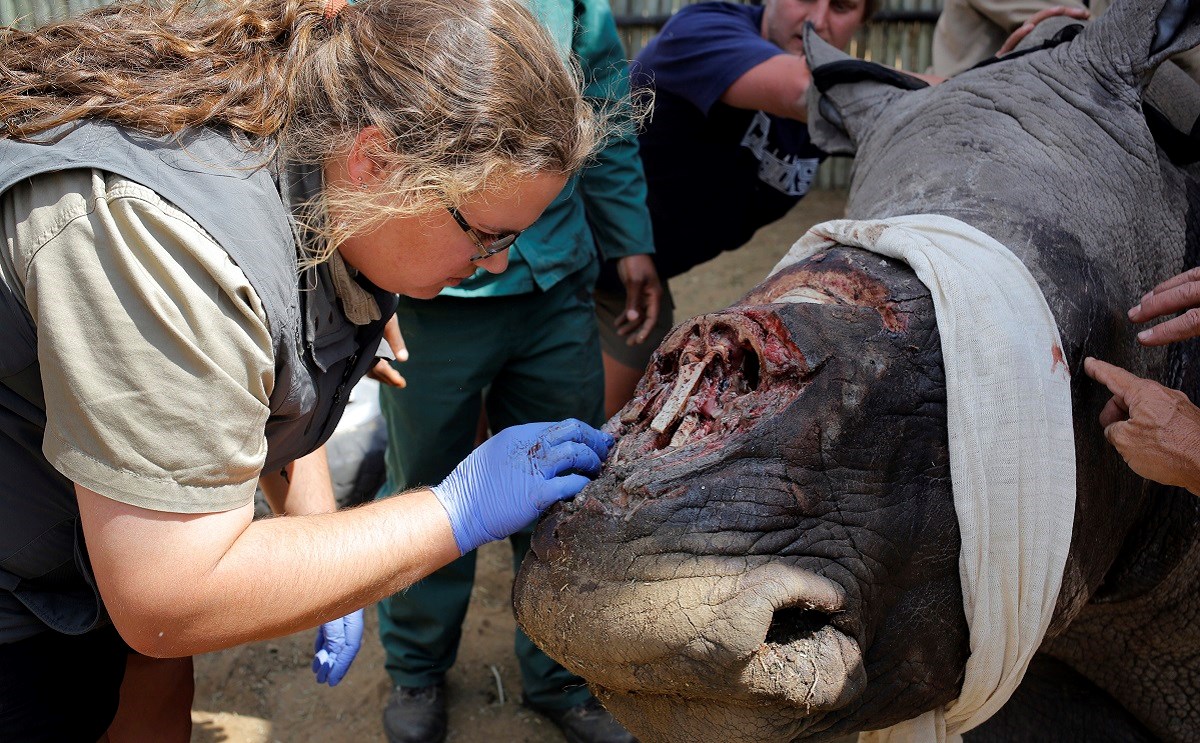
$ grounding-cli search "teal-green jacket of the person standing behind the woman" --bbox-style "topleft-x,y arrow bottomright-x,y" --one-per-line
442,0 -> 654,296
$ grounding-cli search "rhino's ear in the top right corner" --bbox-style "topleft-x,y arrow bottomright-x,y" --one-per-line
1082,0 -> 1200,89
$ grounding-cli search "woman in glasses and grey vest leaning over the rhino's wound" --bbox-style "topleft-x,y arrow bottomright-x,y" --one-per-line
0,0 -> 611,742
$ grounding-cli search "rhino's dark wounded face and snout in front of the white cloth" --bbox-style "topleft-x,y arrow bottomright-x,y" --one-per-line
516,250 -> 966,741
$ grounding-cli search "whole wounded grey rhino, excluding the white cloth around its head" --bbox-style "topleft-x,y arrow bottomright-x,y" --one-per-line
515,0 -> 1200,742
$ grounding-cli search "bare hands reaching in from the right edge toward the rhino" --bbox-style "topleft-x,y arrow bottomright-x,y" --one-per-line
1084,268 -> 1200,496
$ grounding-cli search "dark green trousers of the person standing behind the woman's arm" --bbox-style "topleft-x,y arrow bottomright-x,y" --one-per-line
378,270 -> 604,708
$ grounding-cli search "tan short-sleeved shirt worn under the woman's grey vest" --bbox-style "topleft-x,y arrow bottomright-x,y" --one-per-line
0,169 -> 275,513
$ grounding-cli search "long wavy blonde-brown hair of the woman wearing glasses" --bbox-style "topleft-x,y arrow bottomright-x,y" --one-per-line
0,0 -> 606,254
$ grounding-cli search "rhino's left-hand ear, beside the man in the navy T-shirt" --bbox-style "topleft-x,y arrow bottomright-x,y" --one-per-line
804,22 -> 931,155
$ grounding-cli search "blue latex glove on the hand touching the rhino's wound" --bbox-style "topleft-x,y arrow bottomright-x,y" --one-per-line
432,418 -> 612,555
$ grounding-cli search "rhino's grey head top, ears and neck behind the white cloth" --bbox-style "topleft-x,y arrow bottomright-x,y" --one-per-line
805,2 -> 1200,741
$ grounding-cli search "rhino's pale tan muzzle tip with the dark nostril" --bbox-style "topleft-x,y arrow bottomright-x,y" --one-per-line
516,540 -> 865,720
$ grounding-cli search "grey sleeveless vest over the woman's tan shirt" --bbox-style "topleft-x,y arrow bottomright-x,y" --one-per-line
0,122 -> 396,642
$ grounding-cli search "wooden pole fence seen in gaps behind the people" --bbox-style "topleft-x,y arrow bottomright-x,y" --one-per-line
0,0 -> 942,188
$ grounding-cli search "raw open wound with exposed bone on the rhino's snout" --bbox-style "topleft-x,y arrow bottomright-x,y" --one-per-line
608,306 -> 811,467
